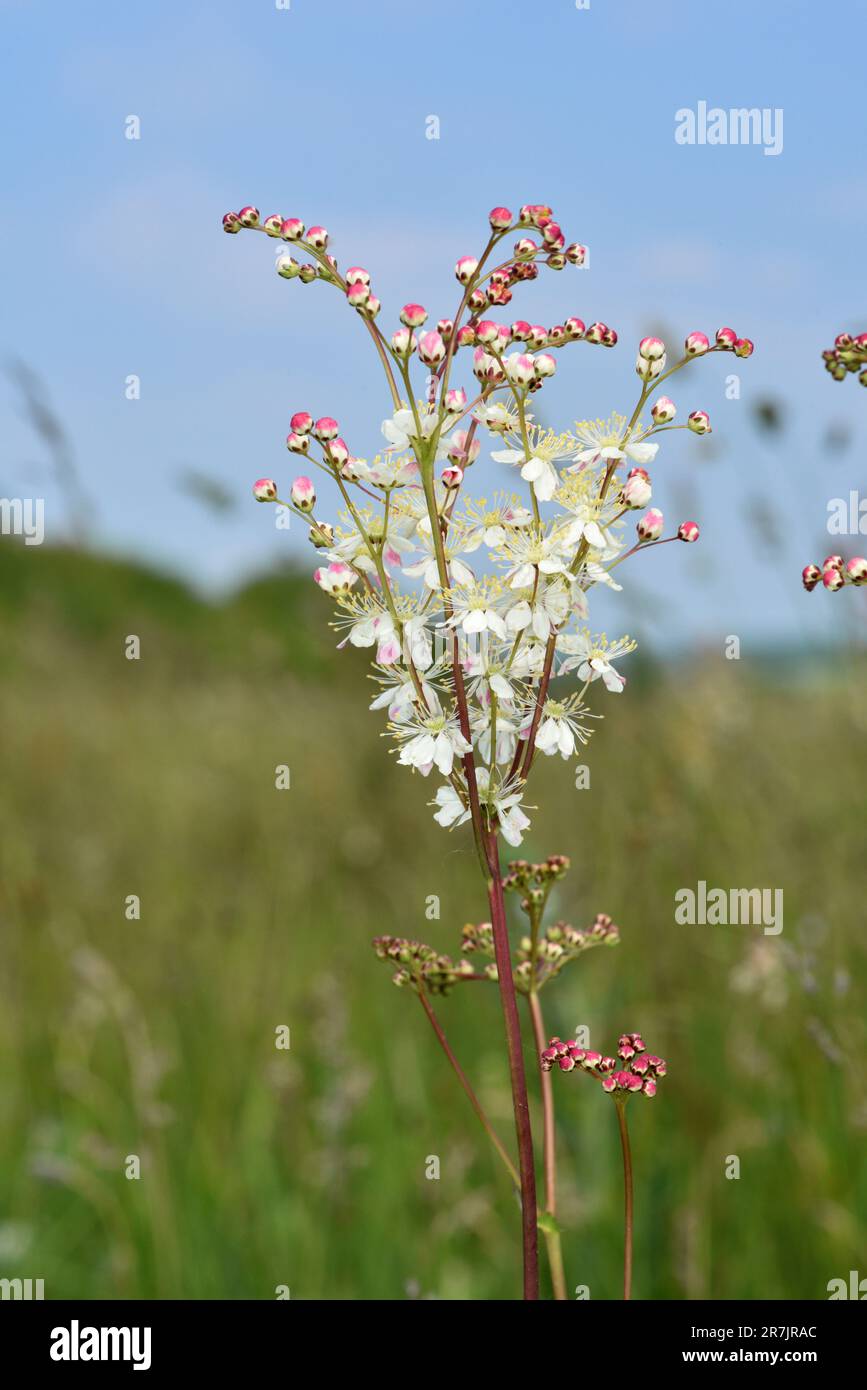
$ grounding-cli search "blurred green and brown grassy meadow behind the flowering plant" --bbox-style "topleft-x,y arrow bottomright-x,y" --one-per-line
0,542 -> 867,1300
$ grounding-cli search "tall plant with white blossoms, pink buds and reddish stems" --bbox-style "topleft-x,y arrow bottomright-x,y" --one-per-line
224,204 -> 753,1298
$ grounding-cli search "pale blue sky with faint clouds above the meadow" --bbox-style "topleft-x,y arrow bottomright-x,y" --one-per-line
0,0 -> 867,646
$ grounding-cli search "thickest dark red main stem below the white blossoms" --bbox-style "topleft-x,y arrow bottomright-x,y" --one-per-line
486,830 -> 539,1301
